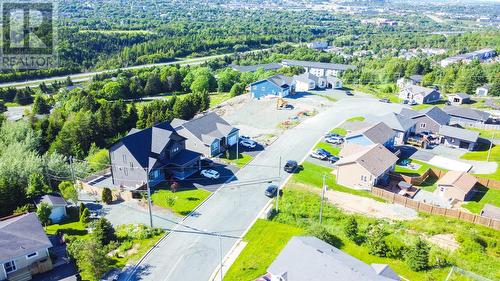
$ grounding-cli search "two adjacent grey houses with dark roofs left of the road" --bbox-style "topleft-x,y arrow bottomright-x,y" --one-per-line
109,112 -> 239,190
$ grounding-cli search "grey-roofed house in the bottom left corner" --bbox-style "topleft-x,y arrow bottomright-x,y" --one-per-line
0,213 -> 52,280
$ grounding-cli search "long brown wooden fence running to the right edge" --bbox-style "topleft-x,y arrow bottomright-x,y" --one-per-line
371,187 -> 500,230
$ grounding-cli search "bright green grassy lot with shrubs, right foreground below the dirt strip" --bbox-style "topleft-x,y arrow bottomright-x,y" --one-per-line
225,189 -> 500,281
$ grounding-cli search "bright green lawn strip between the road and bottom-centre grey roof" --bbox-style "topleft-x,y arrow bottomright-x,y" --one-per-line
224,220 -> 302,280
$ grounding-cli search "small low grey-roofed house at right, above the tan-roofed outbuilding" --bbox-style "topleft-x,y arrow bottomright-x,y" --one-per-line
439,126 -> 479,150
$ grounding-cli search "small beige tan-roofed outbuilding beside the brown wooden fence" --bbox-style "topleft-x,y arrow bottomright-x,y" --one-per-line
436,171 -> 477,201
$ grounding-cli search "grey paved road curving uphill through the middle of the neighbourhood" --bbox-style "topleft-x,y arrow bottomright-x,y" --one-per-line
122,99 -> 401,281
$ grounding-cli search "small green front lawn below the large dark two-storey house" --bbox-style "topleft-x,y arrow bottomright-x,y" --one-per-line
151,189 -> 210,216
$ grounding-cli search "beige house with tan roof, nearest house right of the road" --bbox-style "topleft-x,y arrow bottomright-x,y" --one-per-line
333,144 -> 398,189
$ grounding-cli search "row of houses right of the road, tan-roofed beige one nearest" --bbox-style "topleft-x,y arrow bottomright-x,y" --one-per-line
334,107 -> 492,189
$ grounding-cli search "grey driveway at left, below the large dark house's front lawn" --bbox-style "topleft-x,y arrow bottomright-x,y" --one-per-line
85,200 -> 182,229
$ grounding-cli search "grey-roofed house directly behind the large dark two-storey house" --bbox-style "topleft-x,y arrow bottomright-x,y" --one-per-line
172,112 -> 239,157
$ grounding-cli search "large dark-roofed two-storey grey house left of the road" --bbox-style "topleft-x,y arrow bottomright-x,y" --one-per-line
109,122 -> 201,190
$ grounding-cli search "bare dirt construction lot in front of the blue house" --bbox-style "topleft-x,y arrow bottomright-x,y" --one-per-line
214,94 -> 333,138
